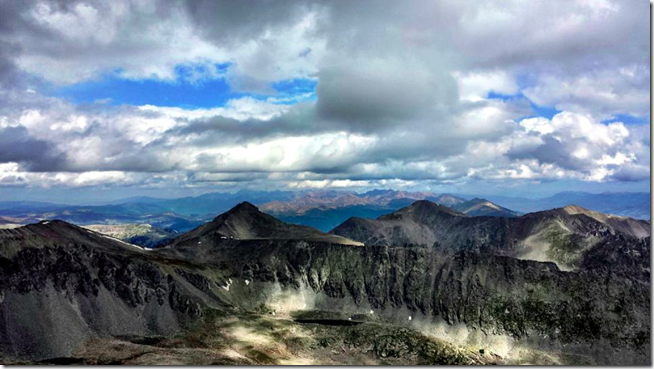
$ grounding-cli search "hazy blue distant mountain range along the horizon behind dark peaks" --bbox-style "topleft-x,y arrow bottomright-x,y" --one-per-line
0,190 -> 650,236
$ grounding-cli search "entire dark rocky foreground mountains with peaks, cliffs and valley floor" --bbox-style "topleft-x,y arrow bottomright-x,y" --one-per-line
0,200 -> 651,365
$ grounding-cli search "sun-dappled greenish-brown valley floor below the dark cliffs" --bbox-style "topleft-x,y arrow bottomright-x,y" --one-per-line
4,308 -> 592,365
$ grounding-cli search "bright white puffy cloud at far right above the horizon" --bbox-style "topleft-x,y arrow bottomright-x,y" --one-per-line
506,112 -> 650,181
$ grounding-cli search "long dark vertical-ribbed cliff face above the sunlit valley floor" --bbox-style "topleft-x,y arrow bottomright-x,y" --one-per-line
168,241 -> 650,352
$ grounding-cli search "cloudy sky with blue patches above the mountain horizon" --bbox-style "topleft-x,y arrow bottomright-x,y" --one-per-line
0,0 -> 650,202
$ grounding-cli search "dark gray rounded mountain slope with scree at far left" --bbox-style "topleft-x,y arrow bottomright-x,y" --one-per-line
0,222 -> 210,359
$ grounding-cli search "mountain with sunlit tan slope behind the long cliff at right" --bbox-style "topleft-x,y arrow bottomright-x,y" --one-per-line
330,201 -> 649,269
